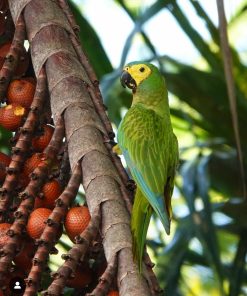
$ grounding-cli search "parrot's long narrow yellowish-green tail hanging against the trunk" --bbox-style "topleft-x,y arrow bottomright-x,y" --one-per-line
131,187 -> 152,272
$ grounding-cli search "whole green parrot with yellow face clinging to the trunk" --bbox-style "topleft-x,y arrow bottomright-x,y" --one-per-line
117,62 -> 178,272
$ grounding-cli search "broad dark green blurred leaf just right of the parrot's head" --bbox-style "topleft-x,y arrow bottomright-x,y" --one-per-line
164,57 -> 247,152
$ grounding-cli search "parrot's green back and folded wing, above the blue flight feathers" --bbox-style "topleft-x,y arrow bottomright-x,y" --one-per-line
118,104 -> 170,194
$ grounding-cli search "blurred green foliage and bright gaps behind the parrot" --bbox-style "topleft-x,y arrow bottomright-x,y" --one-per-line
0,0 -> 247,296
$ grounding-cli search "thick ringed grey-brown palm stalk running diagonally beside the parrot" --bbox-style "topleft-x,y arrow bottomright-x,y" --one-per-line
9,0 -> 150,296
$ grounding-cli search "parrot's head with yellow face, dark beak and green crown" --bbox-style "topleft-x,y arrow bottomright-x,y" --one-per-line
120,62 -> 164,93
